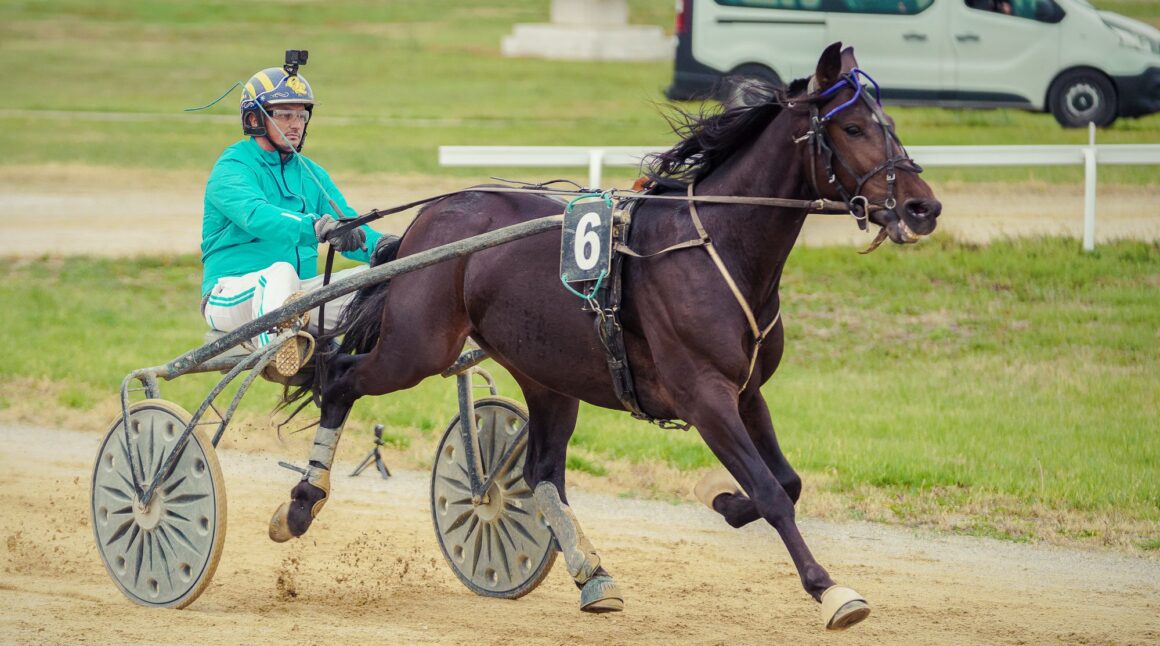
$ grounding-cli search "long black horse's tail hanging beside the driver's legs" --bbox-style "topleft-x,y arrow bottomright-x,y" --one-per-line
276,237 -> 403,424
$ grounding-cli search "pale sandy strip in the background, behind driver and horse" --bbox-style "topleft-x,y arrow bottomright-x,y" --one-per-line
0,166 -> 1160,256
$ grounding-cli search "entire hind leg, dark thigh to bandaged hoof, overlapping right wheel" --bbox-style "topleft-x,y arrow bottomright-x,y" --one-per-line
521,380 -> 624,612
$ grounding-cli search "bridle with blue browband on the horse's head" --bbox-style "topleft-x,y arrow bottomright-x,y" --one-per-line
786,67 -> 922,231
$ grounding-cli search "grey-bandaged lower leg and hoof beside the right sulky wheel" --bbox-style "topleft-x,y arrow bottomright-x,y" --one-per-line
532,482 -> 624,612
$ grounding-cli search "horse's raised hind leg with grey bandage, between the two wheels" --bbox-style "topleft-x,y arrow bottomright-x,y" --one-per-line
269,355 -> 367,543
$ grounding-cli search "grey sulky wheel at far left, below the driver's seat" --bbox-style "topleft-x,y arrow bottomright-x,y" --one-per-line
92,399 -> 225,608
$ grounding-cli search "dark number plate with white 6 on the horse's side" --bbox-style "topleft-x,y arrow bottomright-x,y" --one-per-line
560,199 -> 612,283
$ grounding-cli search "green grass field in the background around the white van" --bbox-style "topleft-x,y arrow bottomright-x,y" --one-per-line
0,0 -> 1160,186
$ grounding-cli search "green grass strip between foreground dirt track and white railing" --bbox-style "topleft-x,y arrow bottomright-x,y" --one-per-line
0,238 -> 1160,531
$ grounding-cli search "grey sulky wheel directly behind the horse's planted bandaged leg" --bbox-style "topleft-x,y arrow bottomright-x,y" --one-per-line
432,397 -> 556,598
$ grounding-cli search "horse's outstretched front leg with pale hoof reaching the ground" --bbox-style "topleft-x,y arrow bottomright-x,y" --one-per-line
686,379 -> 870,630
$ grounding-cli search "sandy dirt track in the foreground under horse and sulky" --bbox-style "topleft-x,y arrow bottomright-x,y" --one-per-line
0,427 -> 1160,644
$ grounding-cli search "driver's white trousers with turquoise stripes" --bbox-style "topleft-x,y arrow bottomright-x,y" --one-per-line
204,262 -> 367,348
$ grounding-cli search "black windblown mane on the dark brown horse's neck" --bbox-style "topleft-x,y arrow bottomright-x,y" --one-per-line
645,79 -> 809,186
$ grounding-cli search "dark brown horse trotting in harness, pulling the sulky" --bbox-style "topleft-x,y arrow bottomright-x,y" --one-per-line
270,43 -> 941,629
